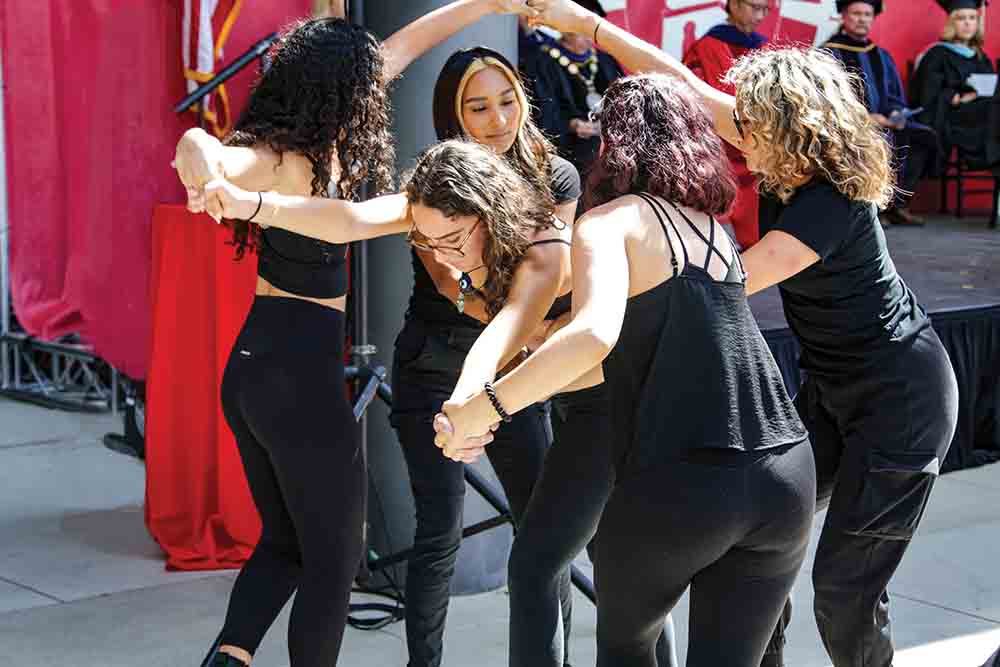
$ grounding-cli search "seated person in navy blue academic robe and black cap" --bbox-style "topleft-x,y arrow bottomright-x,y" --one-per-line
823,0 -> 938,225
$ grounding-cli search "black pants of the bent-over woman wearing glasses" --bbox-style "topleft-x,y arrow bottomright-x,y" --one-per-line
508,385 -> 677,667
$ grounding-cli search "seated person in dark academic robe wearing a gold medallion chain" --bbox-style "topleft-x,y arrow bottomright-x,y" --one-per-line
519,0 -> 623,177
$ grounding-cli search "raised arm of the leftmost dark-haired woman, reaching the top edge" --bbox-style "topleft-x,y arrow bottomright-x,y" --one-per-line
383,0 -> 534,81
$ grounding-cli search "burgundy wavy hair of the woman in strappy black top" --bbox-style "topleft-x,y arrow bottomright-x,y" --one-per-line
584,74 -> 736,215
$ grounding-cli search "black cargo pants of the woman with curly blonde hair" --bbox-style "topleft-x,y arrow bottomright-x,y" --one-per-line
766,328 -> 958,667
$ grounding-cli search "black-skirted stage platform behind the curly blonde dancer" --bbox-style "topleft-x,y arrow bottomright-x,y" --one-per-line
750,217 -> 1000,470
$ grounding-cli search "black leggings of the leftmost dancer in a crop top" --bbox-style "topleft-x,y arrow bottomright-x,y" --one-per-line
221,297 -> 366,667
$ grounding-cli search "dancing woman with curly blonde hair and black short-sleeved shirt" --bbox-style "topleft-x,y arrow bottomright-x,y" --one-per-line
516,0 -> 958,667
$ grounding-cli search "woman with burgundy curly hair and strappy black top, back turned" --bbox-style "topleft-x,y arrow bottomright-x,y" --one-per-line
435,75 -> 815,667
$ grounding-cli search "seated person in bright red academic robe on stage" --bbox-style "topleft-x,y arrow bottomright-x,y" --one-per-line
684,0 -> 771,250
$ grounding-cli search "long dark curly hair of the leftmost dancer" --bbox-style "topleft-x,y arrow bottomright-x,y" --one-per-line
225,18 -> 395,259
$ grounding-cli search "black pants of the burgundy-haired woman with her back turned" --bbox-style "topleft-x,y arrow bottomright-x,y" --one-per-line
595,443 -> 816,667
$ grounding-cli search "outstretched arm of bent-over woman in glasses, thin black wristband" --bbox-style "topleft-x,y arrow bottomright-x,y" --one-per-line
204,179 -> 409,243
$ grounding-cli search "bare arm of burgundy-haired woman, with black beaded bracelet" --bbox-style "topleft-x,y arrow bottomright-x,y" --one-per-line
437,209 -> 629,460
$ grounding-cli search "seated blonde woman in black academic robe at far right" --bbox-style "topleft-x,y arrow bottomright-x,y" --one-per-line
910,0 -> 1000,168
